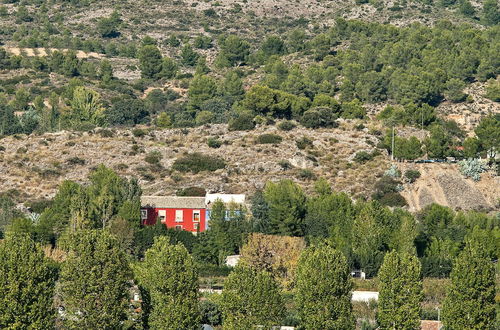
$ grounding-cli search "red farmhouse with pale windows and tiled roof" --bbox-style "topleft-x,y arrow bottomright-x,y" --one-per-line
141,196 -> 207,233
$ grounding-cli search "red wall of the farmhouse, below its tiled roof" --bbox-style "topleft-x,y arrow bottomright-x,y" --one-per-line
142,208 -> 207,232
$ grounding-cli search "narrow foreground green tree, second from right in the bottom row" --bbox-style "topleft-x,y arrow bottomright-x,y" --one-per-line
377,251 -> 423,329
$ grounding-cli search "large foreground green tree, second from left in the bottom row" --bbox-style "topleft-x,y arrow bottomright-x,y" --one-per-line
60,230 -> 131,329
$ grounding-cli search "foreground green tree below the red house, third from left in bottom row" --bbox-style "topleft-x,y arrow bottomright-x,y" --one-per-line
135,236 -> 201,329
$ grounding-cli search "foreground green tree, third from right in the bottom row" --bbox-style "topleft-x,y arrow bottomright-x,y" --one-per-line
296,245 -> 355,330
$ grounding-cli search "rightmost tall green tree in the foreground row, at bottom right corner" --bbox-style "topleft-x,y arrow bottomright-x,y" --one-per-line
443,242 -> 495,330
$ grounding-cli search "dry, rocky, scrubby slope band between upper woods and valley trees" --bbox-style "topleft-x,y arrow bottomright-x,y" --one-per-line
0,121 -> 500,211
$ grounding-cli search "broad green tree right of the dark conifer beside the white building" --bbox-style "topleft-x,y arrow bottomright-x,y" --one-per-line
264,179 -> 306,236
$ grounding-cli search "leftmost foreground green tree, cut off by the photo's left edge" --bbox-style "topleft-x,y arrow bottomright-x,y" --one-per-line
0,234 -> 57,329
